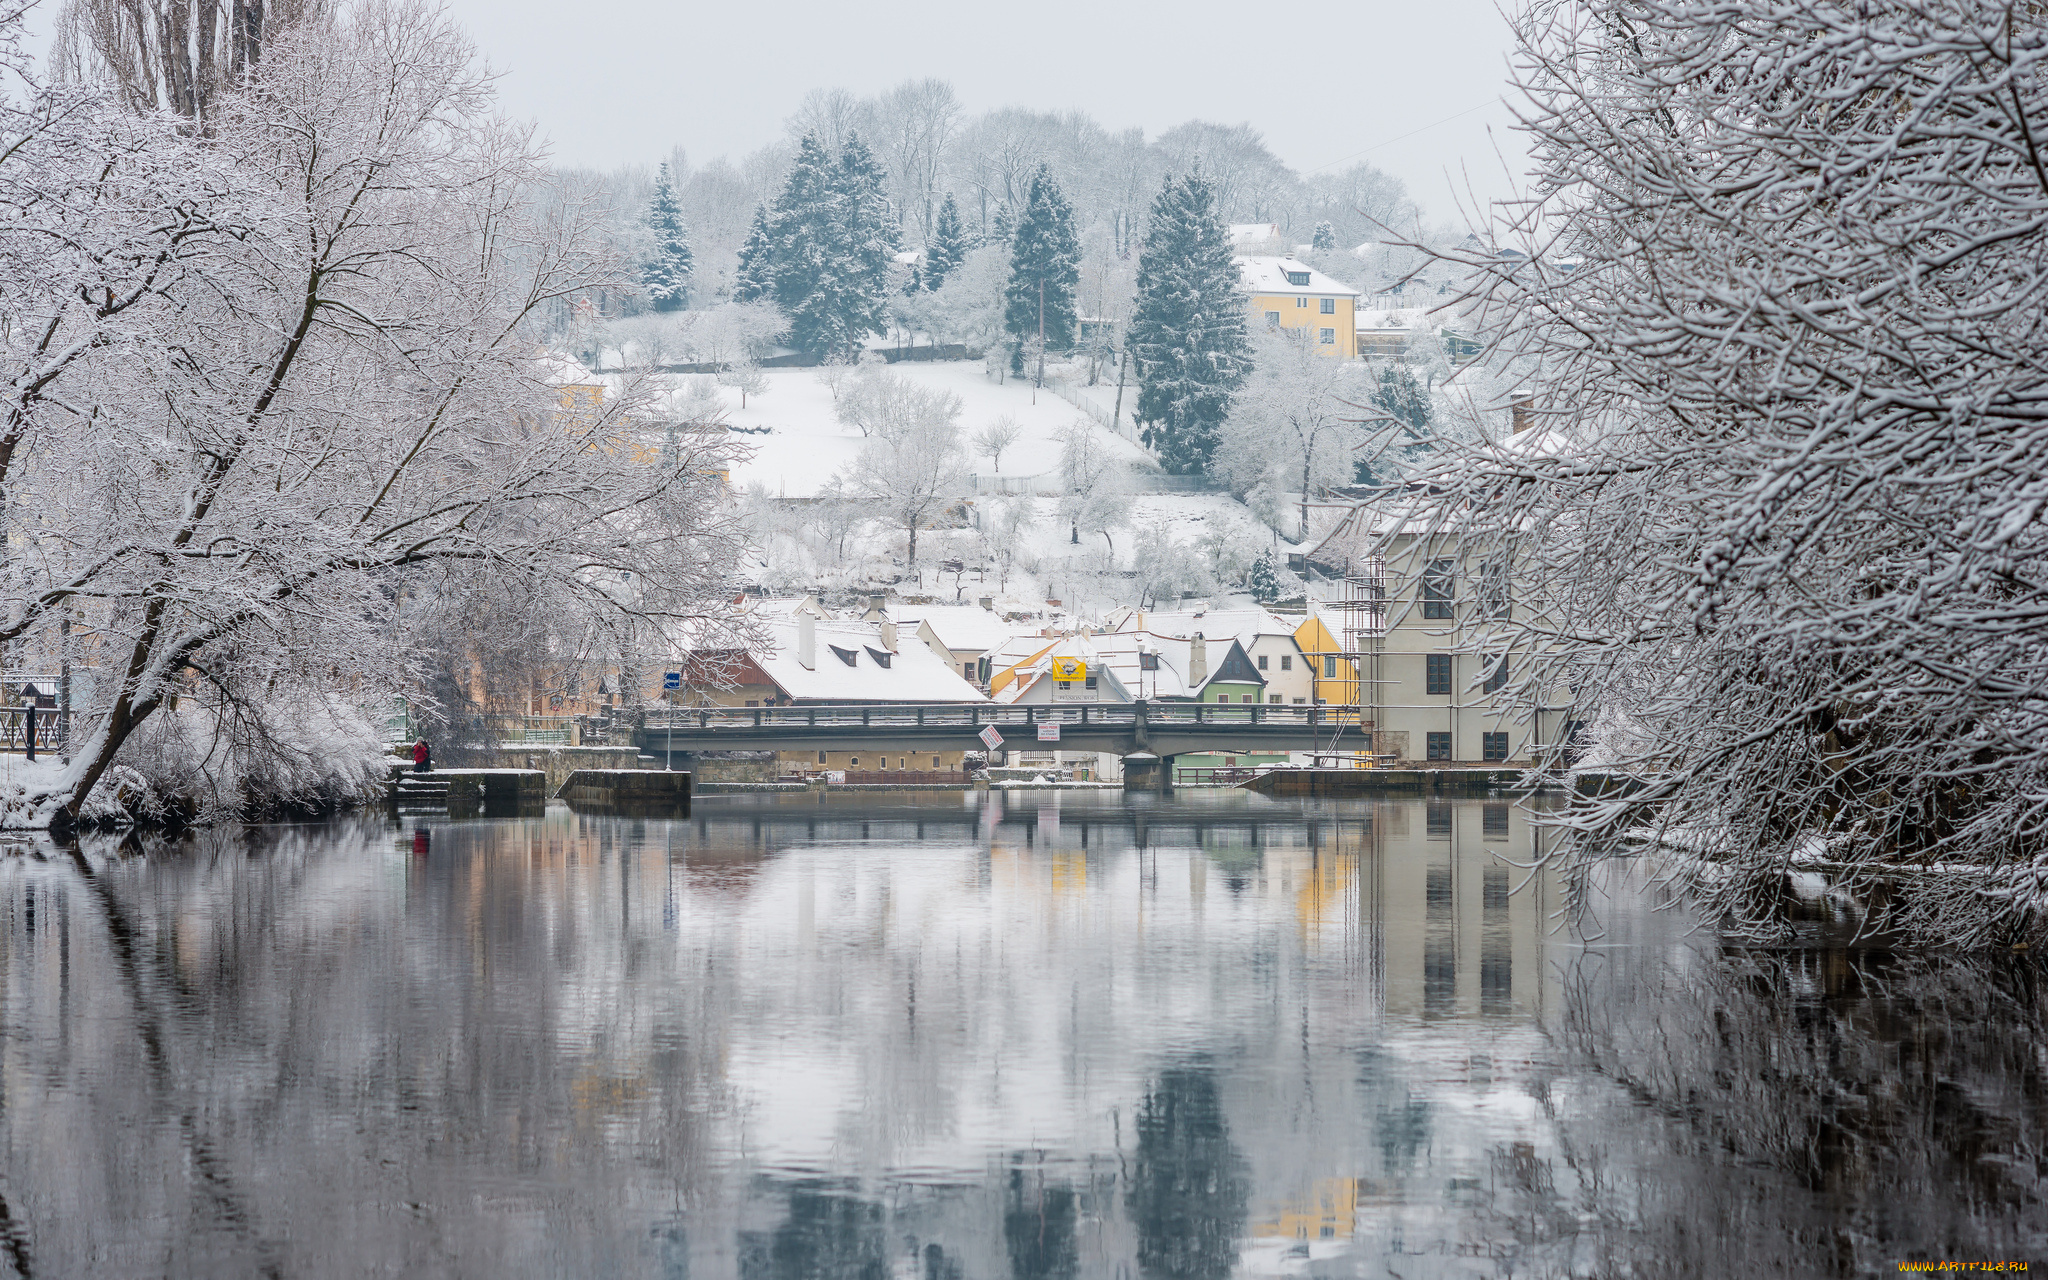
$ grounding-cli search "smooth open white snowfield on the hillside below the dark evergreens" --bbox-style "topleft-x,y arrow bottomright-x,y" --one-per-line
651,360 -> 1157,498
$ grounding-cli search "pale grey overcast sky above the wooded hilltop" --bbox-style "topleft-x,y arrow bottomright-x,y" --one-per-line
436,0 -> 1520,217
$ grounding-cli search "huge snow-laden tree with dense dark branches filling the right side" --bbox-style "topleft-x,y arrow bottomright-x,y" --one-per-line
1425,0 -> 2048,946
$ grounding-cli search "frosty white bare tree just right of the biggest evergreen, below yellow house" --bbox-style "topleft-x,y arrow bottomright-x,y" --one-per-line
1212,330 -> 1360,541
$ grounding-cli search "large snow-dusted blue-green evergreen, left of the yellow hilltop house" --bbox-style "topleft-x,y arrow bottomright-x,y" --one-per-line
1128,172 -> 1251,475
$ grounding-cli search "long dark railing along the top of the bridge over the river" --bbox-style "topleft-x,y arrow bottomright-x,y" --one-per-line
647,702 -> 1360,733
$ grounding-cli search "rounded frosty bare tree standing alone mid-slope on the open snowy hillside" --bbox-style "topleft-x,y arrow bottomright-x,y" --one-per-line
840,367 -> 969,565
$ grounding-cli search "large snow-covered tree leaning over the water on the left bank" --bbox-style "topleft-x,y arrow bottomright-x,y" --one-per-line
0,0 -> 735,823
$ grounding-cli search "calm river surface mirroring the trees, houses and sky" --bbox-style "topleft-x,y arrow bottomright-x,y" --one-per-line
0,793 -> 2048,1280
